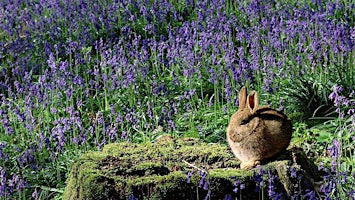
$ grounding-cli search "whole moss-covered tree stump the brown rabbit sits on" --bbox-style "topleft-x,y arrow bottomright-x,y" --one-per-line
63,136 -> 319,200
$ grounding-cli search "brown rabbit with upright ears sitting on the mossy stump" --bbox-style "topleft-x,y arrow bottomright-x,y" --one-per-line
227,87 -> 292,169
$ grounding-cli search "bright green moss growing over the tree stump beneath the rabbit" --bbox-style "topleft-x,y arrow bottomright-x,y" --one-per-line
63,136 -> 320,200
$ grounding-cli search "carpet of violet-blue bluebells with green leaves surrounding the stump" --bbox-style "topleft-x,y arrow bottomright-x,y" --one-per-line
0,0 -> 355,199
